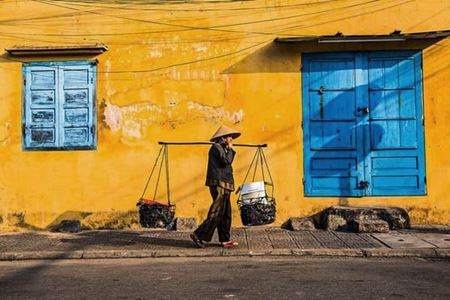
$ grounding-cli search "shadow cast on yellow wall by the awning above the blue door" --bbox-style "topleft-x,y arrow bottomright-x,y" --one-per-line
222,38 -> 443,74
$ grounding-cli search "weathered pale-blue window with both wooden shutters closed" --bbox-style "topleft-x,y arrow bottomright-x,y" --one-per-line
23,61 -> 96,150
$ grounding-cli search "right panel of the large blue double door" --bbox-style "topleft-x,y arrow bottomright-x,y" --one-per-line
367,51 -> 426,196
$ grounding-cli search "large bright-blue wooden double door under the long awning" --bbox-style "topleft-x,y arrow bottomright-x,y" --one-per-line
302,52 -> 425,197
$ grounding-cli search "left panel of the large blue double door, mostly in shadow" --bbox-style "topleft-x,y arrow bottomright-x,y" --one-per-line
303,54 -> 361,196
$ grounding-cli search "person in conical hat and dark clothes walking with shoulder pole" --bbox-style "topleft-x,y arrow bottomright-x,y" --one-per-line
190,126 -> 241,248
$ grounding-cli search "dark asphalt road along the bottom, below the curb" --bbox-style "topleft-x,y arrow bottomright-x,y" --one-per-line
0,257 -> 450,300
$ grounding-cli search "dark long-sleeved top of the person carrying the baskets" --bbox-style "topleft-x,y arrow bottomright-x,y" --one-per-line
206,143 -> 236,191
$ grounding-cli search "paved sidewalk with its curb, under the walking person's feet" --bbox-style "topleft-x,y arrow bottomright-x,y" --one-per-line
0,226 -> 450,260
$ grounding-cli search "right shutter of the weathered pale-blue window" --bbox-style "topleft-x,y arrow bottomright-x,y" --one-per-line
59,64 -> 95,149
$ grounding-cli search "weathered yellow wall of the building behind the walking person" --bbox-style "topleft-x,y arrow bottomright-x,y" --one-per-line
0,0 -> 450,228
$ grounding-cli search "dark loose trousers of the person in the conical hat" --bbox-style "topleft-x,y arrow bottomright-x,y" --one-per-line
194,186 -> 231,242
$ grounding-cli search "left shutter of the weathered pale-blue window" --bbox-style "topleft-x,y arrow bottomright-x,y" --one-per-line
23,65 -> 59,149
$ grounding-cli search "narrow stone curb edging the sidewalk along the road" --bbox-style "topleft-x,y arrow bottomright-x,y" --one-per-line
0,248 -> 450,261
